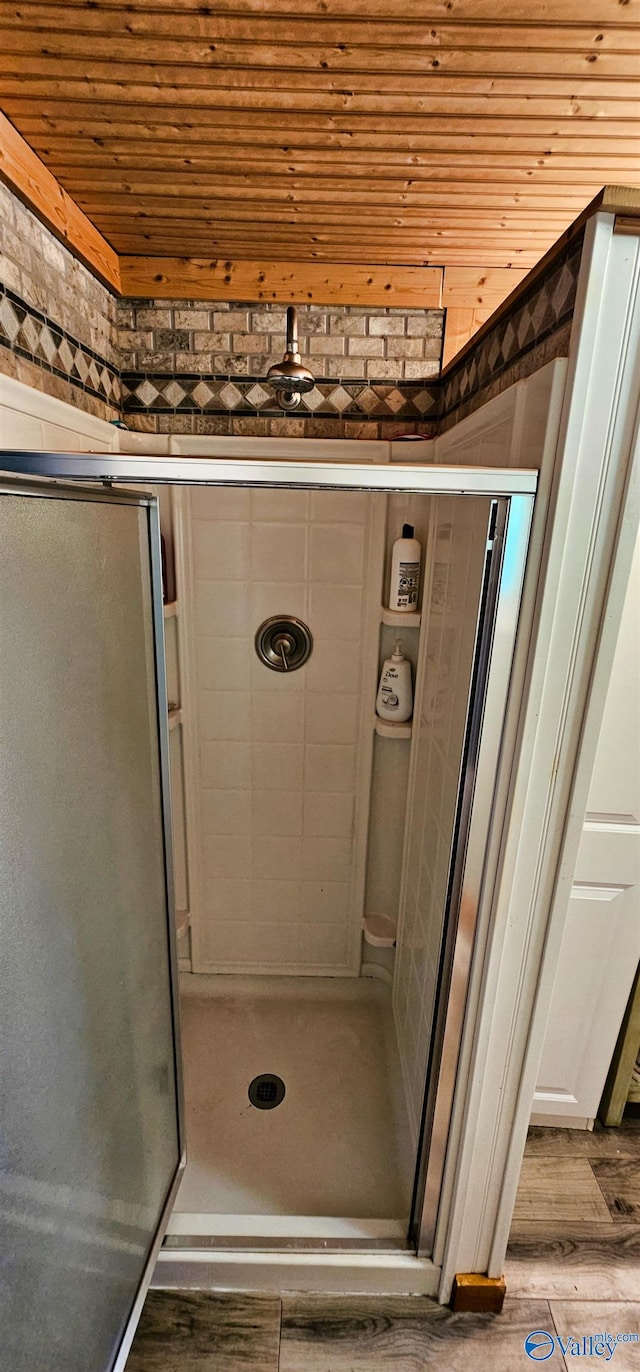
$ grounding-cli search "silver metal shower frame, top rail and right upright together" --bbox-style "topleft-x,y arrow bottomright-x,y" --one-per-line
0,450 -> 538,1258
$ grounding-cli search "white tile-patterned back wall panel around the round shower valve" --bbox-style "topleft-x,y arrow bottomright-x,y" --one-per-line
187,488 -> 382,975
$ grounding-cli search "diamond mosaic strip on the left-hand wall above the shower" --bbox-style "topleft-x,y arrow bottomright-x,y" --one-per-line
0,283 -> 121,409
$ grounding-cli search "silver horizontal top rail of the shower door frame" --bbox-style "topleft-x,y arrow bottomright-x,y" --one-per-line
0,452 -> 538,497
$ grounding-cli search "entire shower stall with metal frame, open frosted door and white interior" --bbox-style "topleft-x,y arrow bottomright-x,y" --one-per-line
0,453 -> 536,1372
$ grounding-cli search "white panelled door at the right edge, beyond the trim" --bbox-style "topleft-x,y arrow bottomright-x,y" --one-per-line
533,524 -> 640,1128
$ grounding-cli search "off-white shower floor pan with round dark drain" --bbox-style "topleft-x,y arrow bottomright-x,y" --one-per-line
166,975 -> 411,1247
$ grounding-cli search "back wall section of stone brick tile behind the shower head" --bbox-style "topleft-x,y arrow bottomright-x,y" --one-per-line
118,299 -> 444,438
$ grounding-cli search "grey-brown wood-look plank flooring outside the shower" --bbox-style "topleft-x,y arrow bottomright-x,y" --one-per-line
128,1120 -> 640,1372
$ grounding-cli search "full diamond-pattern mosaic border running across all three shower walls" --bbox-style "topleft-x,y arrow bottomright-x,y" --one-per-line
0,220 -> 582,435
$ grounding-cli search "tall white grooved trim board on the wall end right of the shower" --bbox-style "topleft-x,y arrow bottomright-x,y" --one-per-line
434,214 -> 640,1301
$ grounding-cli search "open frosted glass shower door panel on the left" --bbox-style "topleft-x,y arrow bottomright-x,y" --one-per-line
0,491 -> 183,1372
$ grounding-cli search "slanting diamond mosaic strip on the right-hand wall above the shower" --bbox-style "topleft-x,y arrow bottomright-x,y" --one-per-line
439,235 -> 584,418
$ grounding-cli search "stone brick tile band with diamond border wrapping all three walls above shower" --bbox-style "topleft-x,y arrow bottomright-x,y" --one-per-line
0,175 -> 582,439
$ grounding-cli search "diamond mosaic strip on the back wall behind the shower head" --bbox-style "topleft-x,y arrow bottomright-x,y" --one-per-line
122,372 -> 439,420
